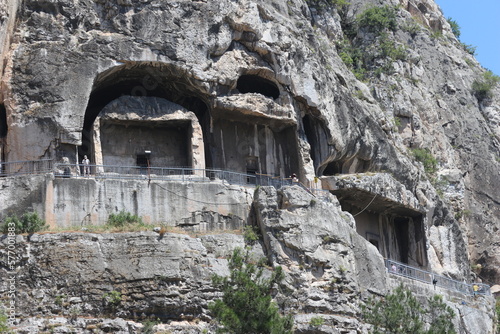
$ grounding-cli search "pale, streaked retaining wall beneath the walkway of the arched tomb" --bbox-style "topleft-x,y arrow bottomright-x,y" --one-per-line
0,174 -> 254,230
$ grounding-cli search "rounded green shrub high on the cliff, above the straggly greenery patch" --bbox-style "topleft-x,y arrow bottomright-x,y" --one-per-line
357,6 -> 397,33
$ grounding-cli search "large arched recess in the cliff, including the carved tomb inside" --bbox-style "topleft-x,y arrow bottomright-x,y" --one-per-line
81,62 -> 210,168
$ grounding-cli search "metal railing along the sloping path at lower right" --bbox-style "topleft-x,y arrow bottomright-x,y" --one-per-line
385,259 -> 491,296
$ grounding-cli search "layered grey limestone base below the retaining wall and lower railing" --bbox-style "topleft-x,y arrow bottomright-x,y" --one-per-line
0,187 -> 494,334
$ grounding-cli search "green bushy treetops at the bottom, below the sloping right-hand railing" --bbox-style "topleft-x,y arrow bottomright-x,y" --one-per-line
363,285 -> 456,334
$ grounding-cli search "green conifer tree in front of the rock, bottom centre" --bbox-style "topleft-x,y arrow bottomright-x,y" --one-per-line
209,248 -> 293,334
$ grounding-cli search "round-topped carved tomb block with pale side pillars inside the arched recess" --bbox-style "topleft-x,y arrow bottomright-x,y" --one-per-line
92,96 -> 205,169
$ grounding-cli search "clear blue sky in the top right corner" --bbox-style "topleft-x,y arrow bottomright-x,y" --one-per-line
434,0 -> 500,75
